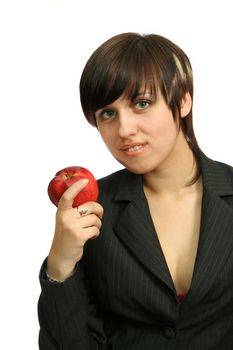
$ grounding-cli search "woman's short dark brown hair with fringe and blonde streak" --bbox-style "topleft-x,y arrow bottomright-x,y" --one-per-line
80,33 -> 201,184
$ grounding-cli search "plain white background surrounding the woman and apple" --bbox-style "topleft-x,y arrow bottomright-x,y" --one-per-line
0,0 -> 233,350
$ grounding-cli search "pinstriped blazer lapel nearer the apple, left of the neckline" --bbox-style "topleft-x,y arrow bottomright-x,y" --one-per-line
113,173 -> 174,291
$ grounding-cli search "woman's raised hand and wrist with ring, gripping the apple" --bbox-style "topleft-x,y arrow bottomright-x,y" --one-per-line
47,179 -> 103,281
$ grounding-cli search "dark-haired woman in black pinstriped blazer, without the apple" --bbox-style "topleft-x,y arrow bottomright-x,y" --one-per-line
38,33 -> 233,350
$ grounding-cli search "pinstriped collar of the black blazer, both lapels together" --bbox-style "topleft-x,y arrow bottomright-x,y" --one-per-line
113,153 -> 233,302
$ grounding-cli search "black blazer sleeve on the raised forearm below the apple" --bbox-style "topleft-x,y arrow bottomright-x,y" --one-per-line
38,260 -> 106,350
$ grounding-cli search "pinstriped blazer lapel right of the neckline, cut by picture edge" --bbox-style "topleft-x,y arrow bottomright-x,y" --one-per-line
188,156 -> 233,303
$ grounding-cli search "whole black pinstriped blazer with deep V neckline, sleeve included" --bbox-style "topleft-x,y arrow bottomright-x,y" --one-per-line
38,154 -> 233,350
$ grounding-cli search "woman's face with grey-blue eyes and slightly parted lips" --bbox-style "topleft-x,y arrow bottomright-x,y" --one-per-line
95,92 -> 186,174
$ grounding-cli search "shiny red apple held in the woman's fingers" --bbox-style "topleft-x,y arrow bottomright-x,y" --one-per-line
48,166 -> 99,208
